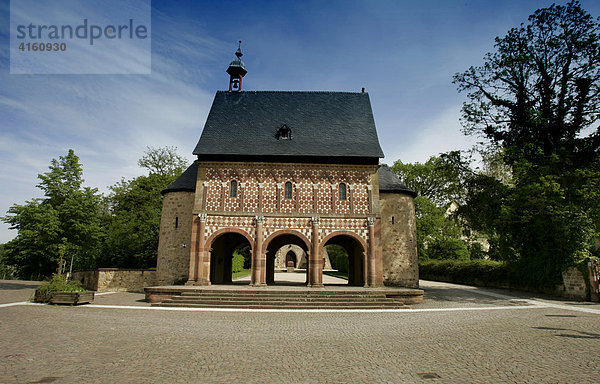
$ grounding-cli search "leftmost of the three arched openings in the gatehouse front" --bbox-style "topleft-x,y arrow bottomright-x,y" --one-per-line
210,232 -> 252,284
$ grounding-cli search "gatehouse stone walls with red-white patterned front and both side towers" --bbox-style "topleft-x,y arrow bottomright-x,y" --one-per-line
157,162 -> 418,287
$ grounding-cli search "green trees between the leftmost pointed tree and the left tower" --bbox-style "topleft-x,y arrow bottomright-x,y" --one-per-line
99,147 -> 189,268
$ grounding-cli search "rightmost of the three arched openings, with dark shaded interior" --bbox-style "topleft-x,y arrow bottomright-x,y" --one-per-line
323,234 -> 365,286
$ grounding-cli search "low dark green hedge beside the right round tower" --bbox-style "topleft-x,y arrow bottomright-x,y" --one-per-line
419,260 -> 510,288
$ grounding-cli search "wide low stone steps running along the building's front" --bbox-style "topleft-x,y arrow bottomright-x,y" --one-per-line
152,289 -> 423,309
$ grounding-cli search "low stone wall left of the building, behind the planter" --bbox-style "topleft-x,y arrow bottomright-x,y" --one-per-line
73,268 -> 156,292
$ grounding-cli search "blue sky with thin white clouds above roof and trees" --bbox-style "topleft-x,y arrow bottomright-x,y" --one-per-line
0,0 -> 600,242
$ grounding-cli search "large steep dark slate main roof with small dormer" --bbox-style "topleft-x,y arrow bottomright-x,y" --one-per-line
193,91 -> 383,160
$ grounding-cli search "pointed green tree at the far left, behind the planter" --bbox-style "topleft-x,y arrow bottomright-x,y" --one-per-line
2,150 -> 102,278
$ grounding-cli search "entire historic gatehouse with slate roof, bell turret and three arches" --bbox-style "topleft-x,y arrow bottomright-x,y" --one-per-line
157,43 -> 418,287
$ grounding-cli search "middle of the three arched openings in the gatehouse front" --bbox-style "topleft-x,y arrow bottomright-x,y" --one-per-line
265,232 -> 309,284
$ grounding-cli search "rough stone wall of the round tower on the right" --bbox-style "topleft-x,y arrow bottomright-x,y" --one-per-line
379,192 -> 419,288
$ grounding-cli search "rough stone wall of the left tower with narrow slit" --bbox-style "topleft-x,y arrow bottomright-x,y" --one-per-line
156,192 -> 194,285
